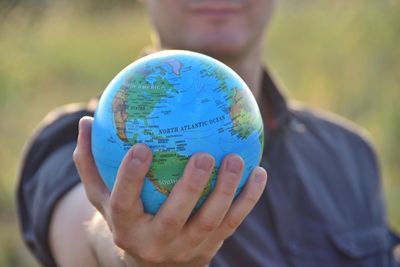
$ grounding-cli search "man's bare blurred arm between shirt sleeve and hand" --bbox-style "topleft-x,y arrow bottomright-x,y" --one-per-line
49,184 -> 130,267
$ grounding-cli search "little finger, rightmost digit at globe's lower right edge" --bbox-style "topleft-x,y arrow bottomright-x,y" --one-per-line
207,167 -> 267,245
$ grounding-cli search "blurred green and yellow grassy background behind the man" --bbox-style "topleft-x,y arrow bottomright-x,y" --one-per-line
0,0 -> 400,267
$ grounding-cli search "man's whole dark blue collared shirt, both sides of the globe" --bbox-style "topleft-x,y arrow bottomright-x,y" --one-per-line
18,70 -> 398,267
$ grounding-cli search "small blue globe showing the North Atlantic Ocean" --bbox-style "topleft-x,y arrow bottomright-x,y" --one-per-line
92,50 -> 264,214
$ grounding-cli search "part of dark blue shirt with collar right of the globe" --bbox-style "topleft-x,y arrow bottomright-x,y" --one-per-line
211,72 -> 396,267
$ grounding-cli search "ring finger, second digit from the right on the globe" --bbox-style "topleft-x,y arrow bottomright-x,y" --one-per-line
185,154 -> 244,246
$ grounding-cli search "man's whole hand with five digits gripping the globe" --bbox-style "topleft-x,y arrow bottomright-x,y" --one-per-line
74,117 -> 267,267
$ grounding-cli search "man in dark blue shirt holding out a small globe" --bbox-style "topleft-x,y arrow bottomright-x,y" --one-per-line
18,0 -> 396,267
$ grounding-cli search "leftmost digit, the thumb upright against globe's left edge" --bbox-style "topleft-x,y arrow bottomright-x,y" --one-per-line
73,116 -> 110,215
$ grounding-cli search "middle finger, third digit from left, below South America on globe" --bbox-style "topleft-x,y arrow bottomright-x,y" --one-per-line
154,153 -> 214,240
